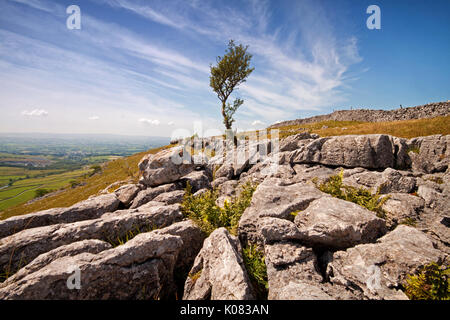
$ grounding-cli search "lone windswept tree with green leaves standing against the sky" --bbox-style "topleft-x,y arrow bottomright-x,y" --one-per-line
209,40 -> 255,129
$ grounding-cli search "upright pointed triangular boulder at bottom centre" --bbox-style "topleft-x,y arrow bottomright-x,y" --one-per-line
183,228 -> 255,300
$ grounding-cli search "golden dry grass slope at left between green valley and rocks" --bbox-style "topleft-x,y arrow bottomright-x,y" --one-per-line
0,146 -> 170,219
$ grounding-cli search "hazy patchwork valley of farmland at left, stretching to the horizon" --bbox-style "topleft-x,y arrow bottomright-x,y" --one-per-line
0,134 -> 168,212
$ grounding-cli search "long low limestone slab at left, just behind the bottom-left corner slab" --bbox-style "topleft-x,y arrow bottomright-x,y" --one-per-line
0,203 -> 183,273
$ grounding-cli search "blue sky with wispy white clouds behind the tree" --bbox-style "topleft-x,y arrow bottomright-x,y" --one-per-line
0,0 -> 450,137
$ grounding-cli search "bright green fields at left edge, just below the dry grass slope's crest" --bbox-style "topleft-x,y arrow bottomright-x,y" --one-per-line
0,167 -> 92,211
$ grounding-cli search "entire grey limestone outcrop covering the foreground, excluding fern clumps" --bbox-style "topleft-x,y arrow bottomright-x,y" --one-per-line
0,127 -> 450,300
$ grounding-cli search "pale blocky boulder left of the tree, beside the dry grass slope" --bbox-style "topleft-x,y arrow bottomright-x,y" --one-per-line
139,147 -> 196,187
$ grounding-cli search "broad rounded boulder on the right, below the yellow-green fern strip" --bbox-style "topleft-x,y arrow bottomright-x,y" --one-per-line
295,198 -> 387,249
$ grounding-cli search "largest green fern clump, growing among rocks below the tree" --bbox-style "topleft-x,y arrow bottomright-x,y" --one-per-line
181,182 -> 256,234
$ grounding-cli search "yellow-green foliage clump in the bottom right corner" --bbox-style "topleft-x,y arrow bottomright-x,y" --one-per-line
405,262 -> 450,300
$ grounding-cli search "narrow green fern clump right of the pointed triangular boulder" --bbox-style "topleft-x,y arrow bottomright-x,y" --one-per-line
242,245 -> 269,299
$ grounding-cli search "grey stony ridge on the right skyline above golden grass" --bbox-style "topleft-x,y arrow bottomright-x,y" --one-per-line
269,101 -> 450,128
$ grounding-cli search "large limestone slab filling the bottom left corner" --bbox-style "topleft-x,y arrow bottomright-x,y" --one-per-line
0,221 -> 204,300
